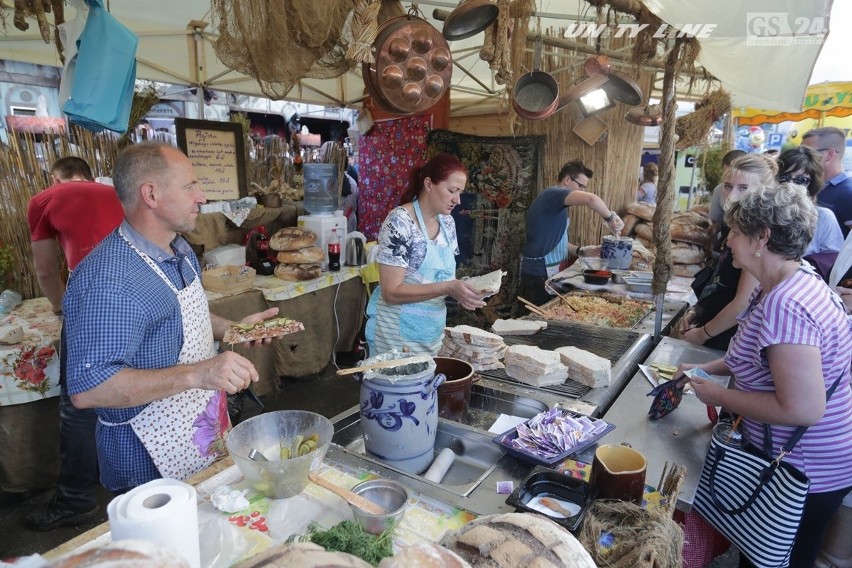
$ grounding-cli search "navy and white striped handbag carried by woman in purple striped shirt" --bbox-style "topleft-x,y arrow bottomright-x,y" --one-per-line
692,378 -> 840,568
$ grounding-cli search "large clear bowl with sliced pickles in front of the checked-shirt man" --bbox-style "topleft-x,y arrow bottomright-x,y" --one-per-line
225,410 -> 334,499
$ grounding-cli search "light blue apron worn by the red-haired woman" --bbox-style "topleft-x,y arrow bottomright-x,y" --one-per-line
366,201 -> 456,356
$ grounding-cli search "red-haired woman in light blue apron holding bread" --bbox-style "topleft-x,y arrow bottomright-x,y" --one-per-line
366,154 -> 485,356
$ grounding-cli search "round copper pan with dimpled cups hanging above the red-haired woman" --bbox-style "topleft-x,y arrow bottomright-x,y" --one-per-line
362,12 -> 453,114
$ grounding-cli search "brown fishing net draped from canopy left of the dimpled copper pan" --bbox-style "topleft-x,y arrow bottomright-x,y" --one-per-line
211,0 -> 354,99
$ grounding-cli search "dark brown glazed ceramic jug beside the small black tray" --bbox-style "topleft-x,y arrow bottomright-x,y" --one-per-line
590,444 -> 647,505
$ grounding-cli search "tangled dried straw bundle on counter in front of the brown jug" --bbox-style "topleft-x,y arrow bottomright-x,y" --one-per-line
577,500 -> 683,568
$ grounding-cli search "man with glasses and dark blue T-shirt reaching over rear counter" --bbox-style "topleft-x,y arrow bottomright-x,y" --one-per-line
520,160 -> 624,306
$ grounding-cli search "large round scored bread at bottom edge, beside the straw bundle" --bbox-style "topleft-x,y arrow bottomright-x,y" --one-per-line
441,513 -> 595,568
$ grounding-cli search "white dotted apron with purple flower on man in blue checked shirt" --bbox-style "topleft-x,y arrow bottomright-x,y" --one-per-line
101,229 -> 231,480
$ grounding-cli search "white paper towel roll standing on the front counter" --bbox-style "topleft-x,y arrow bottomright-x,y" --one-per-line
107,479 -> 201,568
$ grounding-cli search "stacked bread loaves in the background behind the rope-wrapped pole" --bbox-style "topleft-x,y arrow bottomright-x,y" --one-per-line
622,201 -> 712,277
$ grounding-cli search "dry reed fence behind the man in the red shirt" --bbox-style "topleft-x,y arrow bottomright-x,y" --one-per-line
0,124 -> 118,299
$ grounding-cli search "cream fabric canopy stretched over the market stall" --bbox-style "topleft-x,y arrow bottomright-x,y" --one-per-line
0,0 -> 832,113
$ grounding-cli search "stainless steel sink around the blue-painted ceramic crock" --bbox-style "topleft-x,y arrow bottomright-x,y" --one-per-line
331,408 -> 504,496
